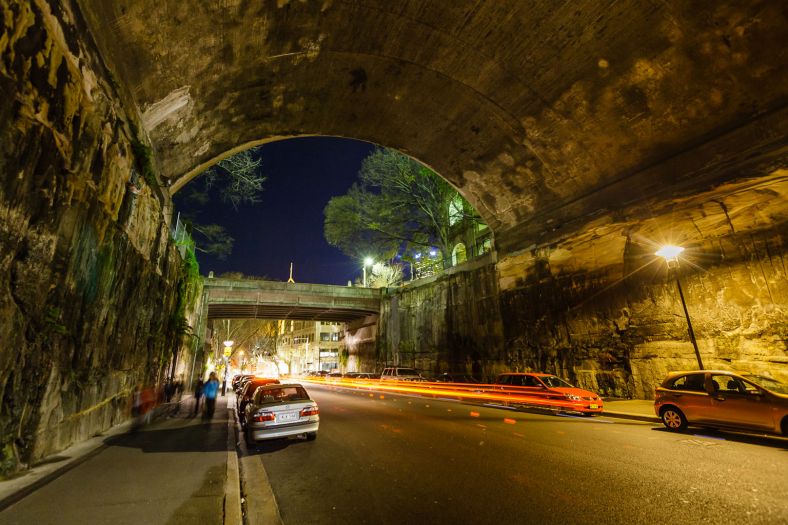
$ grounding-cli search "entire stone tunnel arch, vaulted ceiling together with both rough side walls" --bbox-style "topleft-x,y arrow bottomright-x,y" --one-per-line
0,0 -> 788,474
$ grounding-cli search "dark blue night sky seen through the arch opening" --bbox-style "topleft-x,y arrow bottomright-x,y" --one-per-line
174,137 -> 374,285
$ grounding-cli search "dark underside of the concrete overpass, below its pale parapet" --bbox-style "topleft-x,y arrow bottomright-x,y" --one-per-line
208,304 -> 378,323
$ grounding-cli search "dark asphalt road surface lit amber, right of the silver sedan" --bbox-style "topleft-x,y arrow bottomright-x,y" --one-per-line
253,385 -> 788,525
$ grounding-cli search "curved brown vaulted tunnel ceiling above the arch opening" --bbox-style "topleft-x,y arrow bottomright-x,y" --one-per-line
77,0 -> 788,254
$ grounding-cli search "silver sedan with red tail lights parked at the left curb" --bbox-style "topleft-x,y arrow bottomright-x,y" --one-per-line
244,384 -> 320,444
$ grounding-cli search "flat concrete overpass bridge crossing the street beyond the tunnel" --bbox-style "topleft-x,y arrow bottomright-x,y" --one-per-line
204,278 -> 381,322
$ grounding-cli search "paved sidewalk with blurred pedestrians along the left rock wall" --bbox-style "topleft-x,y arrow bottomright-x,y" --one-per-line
0,396 -> 241,525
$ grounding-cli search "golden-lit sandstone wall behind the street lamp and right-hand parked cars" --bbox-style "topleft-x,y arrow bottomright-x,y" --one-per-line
378,213 -> 788,399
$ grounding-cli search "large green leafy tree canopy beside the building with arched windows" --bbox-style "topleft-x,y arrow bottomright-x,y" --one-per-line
324,149 -> 478,259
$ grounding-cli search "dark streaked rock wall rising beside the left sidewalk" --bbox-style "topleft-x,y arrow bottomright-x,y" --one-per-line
0,0 -> 181,474
